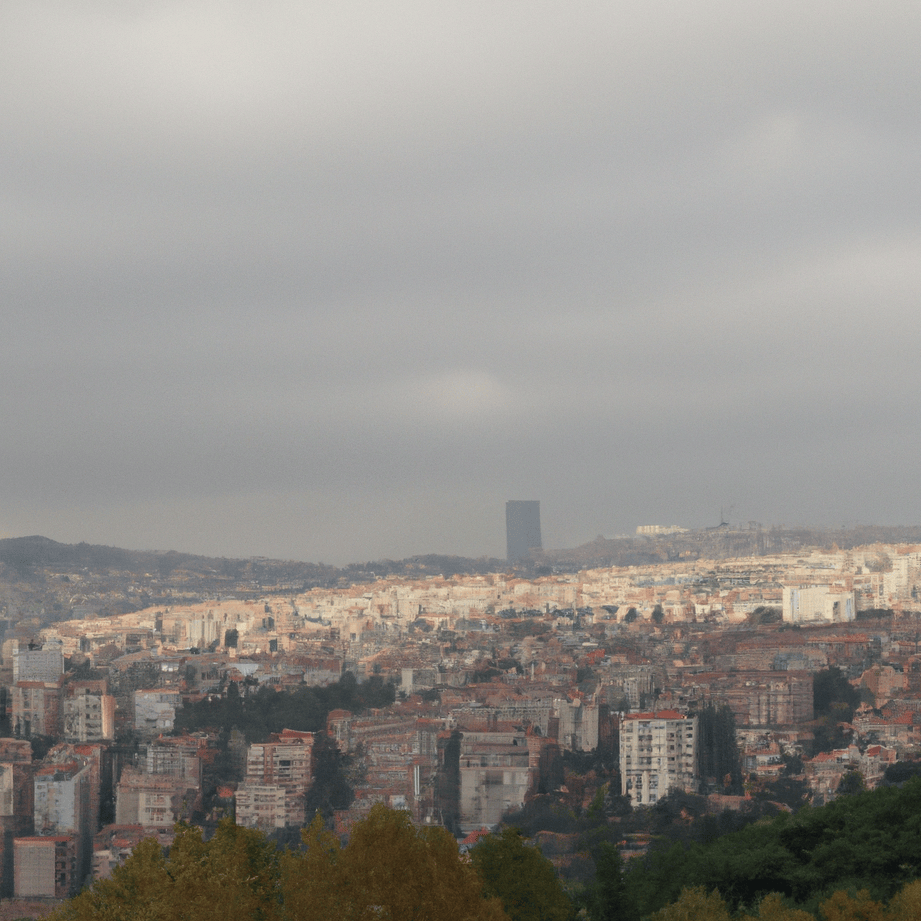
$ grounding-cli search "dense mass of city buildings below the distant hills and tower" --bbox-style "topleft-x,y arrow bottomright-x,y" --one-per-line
0,546 -> 921,898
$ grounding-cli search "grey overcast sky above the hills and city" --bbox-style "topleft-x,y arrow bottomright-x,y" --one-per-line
0,0 -> 921,563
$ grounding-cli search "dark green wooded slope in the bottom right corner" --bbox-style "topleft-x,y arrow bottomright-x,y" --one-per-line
624,779 -> 921,916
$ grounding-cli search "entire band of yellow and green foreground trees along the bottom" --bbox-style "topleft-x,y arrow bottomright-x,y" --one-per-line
43,777 -> 921,921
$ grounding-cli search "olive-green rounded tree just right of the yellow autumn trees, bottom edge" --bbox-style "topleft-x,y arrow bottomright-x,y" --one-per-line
470,828 -> 574,921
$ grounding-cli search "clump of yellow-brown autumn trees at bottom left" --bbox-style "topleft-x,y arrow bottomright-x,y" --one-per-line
51,806 -> 508,921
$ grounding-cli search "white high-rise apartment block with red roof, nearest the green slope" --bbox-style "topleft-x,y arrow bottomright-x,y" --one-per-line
620,710 -> 698,806
